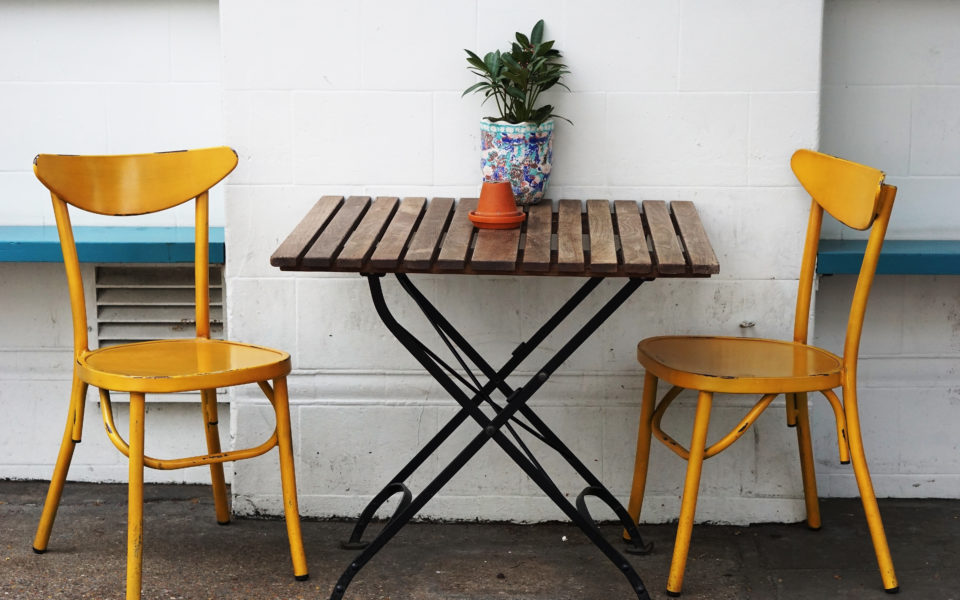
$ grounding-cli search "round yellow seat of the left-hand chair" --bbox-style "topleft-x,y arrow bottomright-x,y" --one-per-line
77,338 -> 290,393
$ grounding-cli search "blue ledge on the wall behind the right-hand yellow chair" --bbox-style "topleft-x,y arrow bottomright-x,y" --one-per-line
817,240 -> 960,275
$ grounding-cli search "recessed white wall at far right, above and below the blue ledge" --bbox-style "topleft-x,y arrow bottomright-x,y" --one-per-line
814,0 -> 960,498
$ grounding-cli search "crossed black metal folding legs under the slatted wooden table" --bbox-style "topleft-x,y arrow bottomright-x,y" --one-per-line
331,275 -> 649,600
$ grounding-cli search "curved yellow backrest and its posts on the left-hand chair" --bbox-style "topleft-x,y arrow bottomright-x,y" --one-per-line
33,146 -> 237,355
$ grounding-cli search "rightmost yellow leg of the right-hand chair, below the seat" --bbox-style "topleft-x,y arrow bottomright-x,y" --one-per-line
843,386 -> 900,594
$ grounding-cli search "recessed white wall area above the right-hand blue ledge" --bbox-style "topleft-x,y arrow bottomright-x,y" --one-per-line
822,0 -> 960,239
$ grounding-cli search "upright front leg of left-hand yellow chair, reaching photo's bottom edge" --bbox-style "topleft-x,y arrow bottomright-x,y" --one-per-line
127,392 -> 145,600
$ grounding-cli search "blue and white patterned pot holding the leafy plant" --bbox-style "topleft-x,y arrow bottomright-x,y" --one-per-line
480,119 -> 553,206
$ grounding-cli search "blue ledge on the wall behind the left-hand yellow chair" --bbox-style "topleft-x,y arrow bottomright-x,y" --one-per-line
0,226 -> 225,264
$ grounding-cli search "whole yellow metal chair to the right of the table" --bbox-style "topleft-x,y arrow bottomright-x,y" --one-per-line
628,150 -> 899,596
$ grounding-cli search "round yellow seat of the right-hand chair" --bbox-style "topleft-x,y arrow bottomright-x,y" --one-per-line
637,336 -> 842,394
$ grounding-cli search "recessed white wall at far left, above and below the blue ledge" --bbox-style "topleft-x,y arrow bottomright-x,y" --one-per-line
0,0 -> 231,482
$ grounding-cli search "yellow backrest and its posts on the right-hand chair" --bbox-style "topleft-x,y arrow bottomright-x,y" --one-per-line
790,150 -> 897,376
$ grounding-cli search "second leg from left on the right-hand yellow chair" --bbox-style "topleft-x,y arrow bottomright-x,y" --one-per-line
667,391 -> 713,597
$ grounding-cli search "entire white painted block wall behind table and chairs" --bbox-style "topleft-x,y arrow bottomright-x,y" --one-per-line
0,0 -> 960,522
